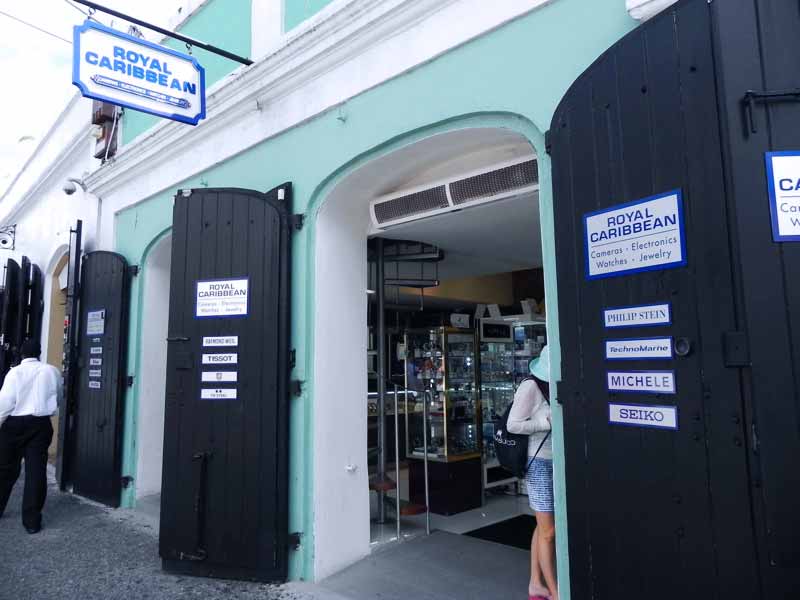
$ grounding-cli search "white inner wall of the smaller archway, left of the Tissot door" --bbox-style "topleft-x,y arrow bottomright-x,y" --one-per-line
134,236 -> 172,498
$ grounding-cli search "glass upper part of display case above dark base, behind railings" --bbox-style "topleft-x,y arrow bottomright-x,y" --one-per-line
405,328 -> 481,462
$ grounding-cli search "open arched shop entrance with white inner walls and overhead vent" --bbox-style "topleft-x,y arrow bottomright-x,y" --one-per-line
313,128 -> 547,597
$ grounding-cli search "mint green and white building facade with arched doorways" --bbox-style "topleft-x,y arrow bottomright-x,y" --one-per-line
0,0 -> 796,598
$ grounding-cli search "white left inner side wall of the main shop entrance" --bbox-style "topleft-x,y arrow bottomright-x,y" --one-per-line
312,179 -> 370,580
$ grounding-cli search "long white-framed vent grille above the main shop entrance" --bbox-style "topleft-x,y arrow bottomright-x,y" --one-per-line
370,157 -> 539,229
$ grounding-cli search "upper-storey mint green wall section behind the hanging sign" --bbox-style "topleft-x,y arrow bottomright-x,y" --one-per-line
122,0 -> 251,144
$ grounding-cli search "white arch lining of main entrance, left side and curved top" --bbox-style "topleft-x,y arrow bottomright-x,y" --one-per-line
312,126 -> 533,580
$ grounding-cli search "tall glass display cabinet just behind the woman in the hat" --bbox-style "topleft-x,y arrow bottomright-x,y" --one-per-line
478,317 -> 547,489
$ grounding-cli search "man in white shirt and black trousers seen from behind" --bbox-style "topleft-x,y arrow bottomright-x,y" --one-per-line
0,340 -> 62,533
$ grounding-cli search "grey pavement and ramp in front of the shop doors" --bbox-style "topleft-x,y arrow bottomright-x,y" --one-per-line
0,472 -> 528,600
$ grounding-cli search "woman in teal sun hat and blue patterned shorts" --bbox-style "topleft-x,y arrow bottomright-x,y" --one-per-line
506,346 -> 558,600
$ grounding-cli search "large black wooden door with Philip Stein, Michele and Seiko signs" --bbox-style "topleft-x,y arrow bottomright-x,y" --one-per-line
550,0 -> 764,600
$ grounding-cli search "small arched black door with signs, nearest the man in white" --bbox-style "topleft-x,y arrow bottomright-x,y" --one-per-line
70,251 -> 130,507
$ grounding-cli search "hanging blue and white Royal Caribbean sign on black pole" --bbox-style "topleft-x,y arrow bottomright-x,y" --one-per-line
72,21 -> 206,125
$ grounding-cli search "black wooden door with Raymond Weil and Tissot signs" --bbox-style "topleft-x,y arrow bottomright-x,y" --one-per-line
160,184 -> 291,581
